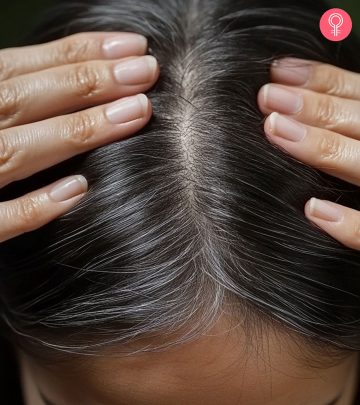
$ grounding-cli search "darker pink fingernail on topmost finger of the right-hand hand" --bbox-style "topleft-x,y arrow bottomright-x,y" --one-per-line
271,58 -> 312,86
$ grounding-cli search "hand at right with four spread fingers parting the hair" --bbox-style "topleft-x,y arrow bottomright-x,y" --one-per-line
258,58 -> 360,250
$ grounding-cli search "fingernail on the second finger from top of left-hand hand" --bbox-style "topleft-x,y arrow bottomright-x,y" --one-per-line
114,55 -> 157,84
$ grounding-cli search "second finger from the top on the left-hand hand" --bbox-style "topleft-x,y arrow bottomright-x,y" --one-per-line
0,55 -> 159,128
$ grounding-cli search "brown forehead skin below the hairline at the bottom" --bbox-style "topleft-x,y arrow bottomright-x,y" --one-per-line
19,318 -> 359,405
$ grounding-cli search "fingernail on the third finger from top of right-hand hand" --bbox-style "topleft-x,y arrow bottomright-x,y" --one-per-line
269,113 -> 307,142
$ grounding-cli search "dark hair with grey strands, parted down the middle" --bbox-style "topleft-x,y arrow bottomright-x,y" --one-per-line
0,0 -> 360,366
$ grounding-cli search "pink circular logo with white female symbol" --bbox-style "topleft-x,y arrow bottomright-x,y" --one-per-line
320,8 -> 352,41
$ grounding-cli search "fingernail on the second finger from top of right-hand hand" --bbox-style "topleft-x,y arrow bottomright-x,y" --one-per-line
264,84 -> 303,114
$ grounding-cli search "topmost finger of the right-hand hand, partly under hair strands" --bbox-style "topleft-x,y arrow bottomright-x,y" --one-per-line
271,58 -> 360,100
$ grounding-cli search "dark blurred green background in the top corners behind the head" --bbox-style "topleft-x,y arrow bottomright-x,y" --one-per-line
0,0 -> 360,48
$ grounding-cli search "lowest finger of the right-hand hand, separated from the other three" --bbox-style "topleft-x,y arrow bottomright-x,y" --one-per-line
305,198 -> 360,250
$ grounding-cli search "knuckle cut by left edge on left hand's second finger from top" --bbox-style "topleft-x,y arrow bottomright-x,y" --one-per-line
0,82 -> 23,128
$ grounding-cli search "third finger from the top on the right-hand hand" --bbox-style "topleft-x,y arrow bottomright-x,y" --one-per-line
264,112 -> 360,186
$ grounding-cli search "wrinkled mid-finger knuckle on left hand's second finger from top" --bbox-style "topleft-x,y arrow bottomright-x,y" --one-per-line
70,63 -> 100,98
